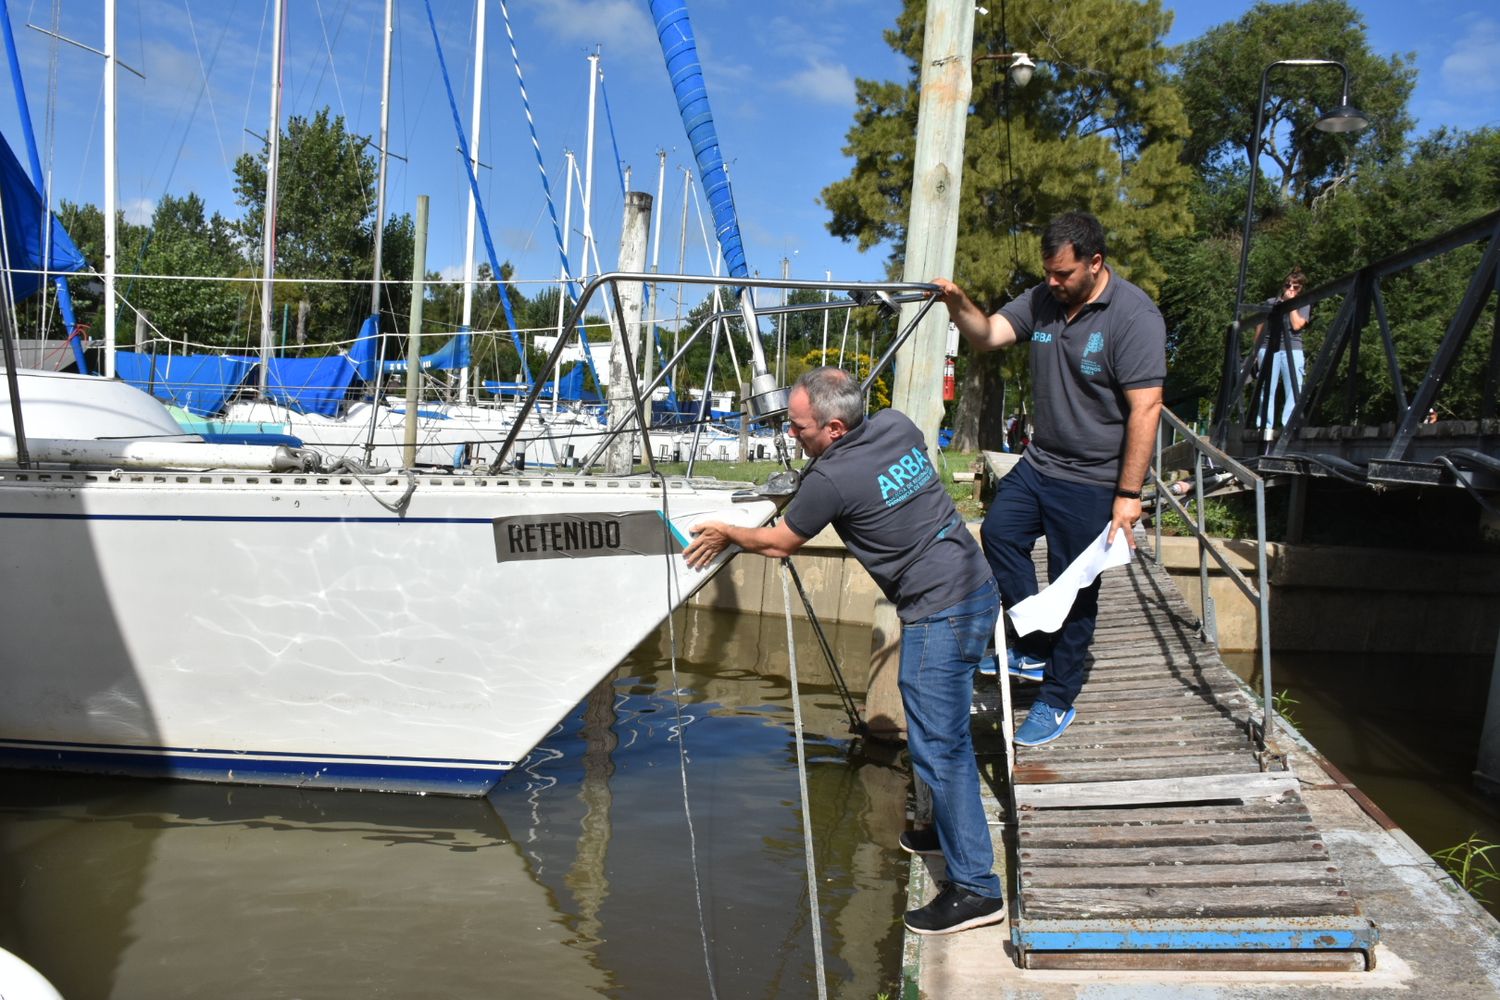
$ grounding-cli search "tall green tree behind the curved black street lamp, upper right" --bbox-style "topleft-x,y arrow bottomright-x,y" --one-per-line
1179,0 -> 1416,204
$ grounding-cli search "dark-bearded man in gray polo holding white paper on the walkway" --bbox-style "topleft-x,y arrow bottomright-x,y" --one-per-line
933,211 -> 1167,747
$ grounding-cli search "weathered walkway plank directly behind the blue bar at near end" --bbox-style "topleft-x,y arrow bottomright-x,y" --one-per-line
1022,886 -> 1358,921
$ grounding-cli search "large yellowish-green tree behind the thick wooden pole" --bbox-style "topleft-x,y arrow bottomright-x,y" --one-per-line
822,0 -> 1193,447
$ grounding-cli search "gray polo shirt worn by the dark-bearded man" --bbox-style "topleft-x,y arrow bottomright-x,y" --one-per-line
1001,263 -> 1167,486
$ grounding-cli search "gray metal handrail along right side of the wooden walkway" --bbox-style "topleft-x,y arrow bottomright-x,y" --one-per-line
1151,406 -> 1277,754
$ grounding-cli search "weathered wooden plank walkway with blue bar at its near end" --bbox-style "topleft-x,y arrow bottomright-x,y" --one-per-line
977,537 -> 1379,970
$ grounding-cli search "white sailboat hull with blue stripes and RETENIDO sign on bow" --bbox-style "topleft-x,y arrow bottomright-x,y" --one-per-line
0,376 -> 774,795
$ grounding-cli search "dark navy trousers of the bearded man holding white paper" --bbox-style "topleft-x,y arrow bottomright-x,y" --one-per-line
980,459 -> 1115,709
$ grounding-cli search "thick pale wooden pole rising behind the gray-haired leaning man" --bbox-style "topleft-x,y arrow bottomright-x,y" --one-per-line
864,3 -> 974,736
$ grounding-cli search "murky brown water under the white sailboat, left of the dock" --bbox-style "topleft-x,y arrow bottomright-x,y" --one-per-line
0,612 -> 906,1000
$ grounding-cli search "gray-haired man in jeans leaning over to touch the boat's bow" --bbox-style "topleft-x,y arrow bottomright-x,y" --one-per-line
684,367 -> 1005,934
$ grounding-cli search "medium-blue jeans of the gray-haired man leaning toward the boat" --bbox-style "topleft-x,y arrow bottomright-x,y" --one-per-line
900,582 -> 1001,897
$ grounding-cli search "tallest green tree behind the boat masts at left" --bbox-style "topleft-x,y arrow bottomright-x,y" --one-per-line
234,108 -> 375,342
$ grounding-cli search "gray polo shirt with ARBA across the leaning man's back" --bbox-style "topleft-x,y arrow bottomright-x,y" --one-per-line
785,409 -> 990,622
